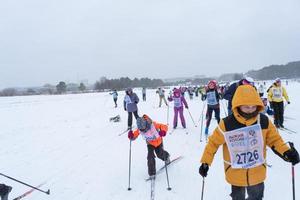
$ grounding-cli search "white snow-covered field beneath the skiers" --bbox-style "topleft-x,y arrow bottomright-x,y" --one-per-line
0,82 -> 300,200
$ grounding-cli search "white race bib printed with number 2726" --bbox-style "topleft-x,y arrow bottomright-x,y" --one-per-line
224,124 -> 265,169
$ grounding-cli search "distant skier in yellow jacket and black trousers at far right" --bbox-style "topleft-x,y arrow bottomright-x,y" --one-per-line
268,78 -> 290,128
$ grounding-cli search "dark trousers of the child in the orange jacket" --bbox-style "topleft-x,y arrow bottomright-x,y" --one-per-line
147,144 -> 170,176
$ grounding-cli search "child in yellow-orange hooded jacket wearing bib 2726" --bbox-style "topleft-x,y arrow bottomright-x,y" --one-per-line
199,85 -> 300,200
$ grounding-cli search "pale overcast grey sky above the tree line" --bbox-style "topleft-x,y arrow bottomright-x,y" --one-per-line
0,0 -> 300,88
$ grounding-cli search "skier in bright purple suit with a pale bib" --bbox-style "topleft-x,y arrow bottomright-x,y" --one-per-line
168,88 -> 188,129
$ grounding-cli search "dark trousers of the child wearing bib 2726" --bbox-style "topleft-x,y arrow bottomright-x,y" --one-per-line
230,182 -> 265,200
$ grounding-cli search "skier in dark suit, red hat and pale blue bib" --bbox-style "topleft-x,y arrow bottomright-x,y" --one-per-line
203,80 -> 220,138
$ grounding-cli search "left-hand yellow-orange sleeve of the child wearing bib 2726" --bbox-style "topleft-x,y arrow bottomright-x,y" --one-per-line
200,120 -> 225,165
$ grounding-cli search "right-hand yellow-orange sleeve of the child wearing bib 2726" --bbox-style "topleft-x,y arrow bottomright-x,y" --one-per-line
266,120 -> 289,155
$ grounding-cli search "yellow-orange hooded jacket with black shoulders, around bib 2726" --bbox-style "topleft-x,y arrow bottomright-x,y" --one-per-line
200,85 -> 289,187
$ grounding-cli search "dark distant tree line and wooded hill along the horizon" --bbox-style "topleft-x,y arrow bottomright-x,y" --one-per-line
0,61 -> 300,96
